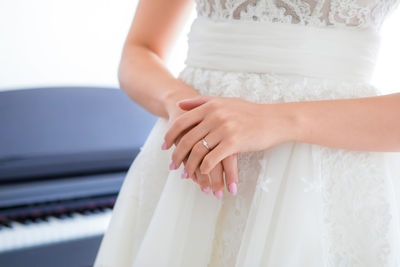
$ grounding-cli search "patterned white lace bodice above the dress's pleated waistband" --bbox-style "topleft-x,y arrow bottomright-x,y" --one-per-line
195,0 -> 400,31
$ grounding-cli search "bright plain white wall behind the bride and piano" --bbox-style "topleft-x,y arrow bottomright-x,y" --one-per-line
0,0 -> 400,92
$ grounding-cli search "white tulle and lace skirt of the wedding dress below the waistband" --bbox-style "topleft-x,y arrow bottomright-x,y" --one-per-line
95,66 -> 400,267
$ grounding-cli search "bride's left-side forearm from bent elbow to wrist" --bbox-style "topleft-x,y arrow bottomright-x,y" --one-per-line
118,45 -> 199,118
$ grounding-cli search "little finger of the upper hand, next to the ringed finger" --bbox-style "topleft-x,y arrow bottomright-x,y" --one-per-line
199,139 -> 236,177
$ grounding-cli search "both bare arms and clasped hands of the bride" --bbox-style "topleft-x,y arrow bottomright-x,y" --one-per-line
119,0 -> 400,199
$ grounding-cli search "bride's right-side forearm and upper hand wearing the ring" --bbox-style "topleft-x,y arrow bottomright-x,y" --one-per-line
165,93 -> 400,180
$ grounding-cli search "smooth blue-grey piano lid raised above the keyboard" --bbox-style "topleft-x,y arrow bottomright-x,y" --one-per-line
0,87 -> 157,185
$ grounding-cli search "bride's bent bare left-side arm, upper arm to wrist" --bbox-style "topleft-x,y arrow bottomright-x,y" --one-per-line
118,0 -> 198,118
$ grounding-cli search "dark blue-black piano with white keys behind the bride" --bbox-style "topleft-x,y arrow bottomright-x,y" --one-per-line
0,87 -> 157,267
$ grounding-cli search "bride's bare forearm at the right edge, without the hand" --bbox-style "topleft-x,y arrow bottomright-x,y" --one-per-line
284,94 -> 400,151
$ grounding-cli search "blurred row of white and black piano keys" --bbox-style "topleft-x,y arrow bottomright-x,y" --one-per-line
0,208 -> 112,253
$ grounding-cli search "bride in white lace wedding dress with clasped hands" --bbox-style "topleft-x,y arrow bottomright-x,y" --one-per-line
95,0 -> 400,267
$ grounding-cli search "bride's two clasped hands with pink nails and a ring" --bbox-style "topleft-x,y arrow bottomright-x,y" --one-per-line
162,95 -> 290,199
